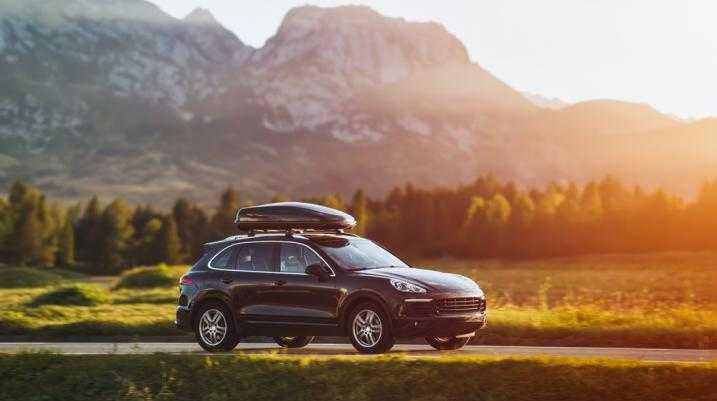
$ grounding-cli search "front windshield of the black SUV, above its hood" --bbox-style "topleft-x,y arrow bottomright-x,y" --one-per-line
318,238 -> 408,270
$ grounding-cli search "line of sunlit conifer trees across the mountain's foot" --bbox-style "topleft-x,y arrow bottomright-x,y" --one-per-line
0,175 -> 717,274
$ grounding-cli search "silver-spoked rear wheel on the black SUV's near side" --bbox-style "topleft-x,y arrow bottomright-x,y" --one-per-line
194,302 -> 239,352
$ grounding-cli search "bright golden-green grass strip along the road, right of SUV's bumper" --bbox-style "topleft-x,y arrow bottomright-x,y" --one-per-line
473,306 -> 717,349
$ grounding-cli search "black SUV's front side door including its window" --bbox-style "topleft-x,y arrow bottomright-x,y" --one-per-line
249,241 -> 340,334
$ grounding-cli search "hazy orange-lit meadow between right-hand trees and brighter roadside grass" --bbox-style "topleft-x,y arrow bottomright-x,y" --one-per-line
416,252 -> 717,310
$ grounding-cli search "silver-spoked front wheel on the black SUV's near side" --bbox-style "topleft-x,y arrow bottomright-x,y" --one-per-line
348,302 -> 395,354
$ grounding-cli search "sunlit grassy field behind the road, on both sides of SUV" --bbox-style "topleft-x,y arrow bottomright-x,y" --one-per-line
0,253 -> 717,348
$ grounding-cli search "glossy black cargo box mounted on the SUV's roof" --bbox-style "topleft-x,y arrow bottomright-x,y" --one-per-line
234,202 -> 356,231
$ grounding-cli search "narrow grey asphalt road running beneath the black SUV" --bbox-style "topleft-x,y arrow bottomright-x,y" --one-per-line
0,342 -> 717,362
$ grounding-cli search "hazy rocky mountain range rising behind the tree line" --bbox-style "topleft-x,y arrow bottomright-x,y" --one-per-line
0,0 -> 713,205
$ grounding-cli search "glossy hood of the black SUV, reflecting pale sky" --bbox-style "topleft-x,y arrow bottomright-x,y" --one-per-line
356,267 -> 482,293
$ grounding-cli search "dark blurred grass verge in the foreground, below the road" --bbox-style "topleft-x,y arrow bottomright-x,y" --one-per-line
0,354 -> 717,401
